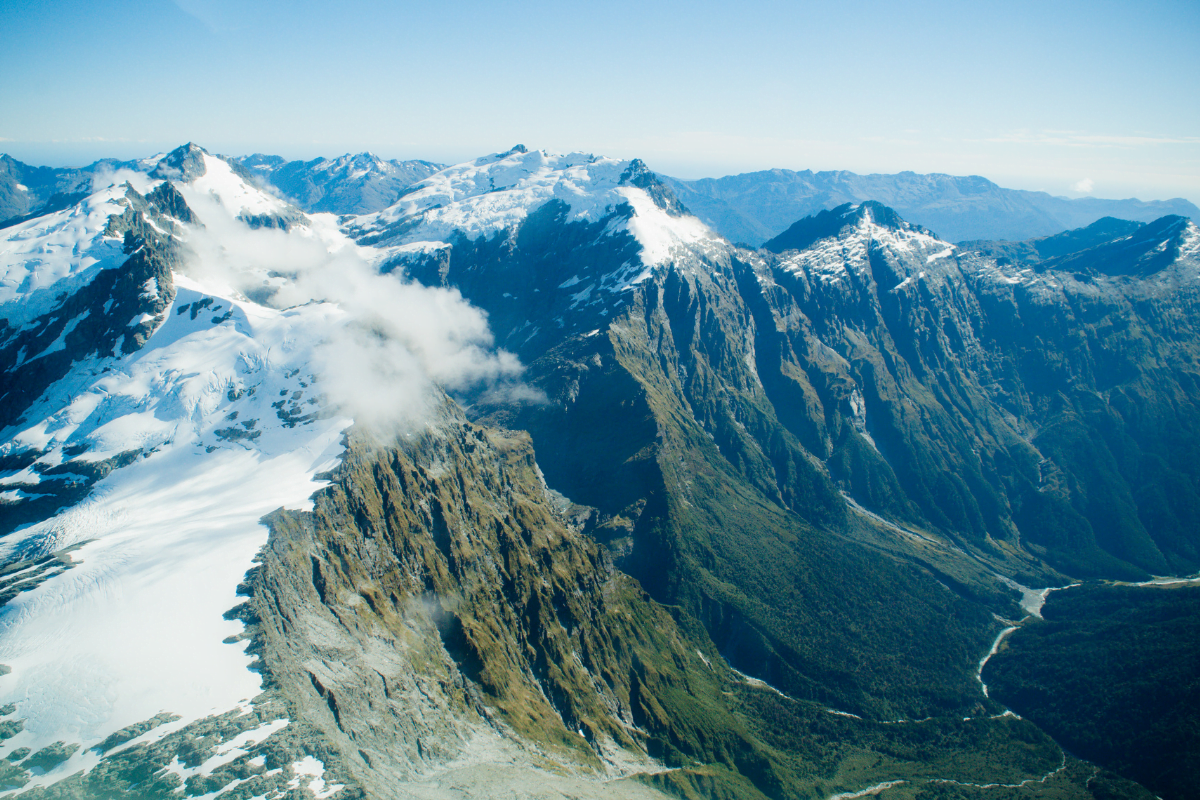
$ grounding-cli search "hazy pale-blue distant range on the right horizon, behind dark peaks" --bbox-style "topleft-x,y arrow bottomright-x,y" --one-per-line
662,169 -> 1200,245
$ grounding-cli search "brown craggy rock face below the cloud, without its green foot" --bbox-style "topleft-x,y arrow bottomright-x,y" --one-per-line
244,417 -> 702,786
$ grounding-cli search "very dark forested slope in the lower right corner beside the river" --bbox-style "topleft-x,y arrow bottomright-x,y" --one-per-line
983,585 -> 1200,800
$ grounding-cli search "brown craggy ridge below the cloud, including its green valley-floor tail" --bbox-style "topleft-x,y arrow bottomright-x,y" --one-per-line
239,417 -> 1060,798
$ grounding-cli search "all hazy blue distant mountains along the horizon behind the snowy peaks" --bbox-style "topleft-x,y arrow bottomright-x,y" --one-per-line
7,152 -> 1200,247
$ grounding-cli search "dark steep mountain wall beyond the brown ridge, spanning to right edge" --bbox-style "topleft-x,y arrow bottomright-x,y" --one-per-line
382,173 -> 1198,716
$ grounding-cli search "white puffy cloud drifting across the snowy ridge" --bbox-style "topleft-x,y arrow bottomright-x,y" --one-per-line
180,186 -> 522,434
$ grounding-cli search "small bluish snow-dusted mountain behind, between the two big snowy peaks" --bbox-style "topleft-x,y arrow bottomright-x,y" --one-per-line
238,152 -> 444,215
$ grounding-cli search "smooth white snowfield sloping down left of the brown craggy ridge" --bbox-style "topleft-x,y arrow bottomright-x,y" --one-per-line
0,276 -> 350,776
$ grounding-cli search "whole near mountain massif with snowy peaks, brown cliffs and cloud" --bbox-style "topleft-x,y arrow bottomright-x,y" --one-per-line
0,145 -> 1180,800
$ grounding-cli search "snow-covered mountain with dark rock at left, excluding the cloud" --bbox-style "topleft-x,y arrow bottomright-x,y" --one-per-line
0,145 -> 349,784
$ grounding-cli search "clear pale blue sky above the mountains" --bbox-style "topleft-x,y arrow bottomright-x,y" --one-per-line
0,0 -> 1200,204
